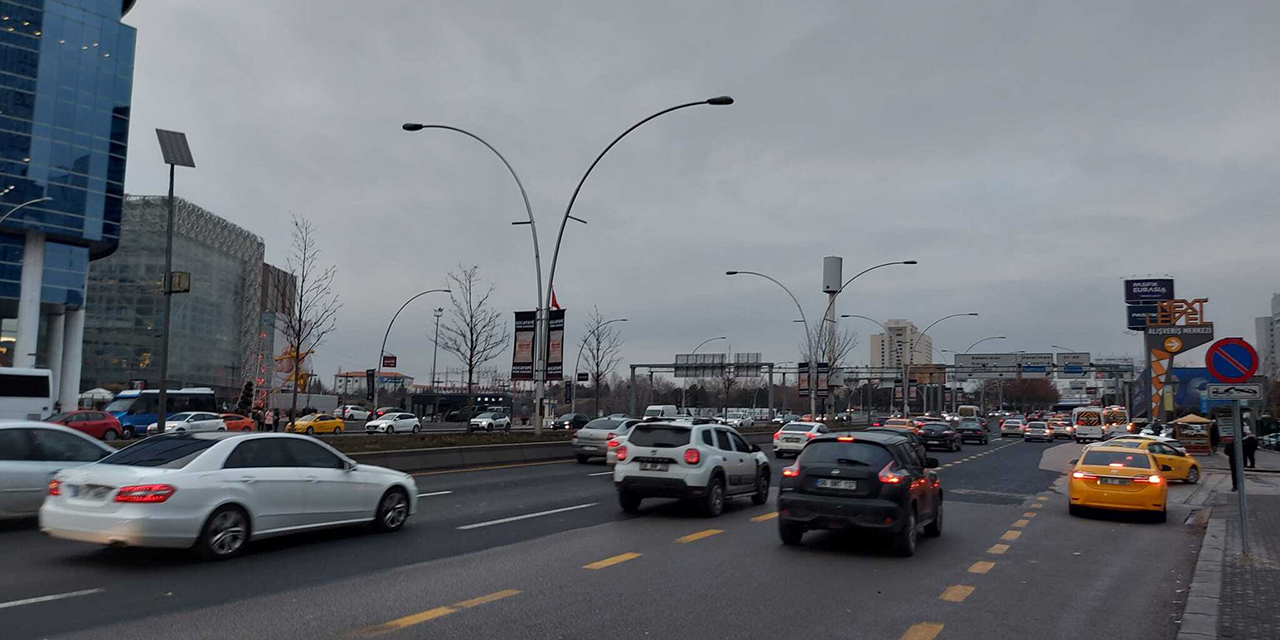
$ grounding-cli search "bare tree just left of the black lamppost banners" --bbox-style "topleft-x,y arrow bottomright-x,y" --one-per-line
436,265 -> 508,413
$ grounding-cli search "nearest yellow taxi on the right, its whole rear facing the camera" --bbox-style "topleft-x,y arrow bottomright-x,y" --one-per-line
1068,445 -> 1169,522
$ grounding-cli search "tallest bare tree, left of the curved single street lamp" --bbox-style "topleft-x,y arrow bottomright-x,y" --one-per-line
273,215 -> 342,417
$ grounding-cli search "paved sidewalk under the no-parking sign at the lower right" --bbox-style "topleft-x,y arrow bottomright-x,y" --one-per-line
1178,465 -> 1280,640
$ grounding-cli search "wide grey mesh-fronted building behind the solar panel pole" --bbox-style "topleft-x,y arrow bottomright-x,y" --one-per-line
84,196 -> 265,399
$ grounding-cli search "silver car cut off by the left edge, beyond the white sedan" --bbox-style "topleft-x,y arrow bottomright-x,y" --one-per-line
0,420 -> 115,520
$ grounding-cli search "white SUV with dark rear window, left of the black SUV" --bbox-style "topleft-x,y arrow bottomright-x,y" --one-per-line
613,420 -> 769,517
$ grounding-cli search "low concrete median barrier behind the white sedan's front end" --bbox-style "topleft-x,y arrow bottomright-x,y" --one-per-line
347,433 -> 773,474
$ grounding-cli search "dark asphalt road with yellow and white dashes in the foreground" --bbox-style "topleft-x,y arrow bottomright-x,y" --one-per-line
0,439 -> 1197,640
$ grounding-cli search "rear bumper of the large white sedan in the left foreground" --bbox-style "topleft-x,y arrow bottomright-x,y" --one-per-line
40,504 -> 204,549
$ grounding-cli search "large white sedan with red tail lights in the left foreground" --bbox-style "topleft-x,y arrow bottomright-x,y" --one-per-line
40,433 -> 417,559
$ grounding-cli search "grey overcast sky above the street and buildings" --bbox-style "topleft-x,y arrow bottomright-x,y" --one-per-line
115,0 -> 1280,381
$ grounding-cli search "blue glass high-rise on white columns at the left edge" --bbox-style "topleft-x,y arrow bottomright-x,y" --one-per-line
0,0 -> 136,406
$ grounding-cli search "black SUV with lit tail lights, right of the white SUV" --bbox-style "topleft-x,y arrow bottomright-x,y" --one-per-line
778,431 -> 942,556
